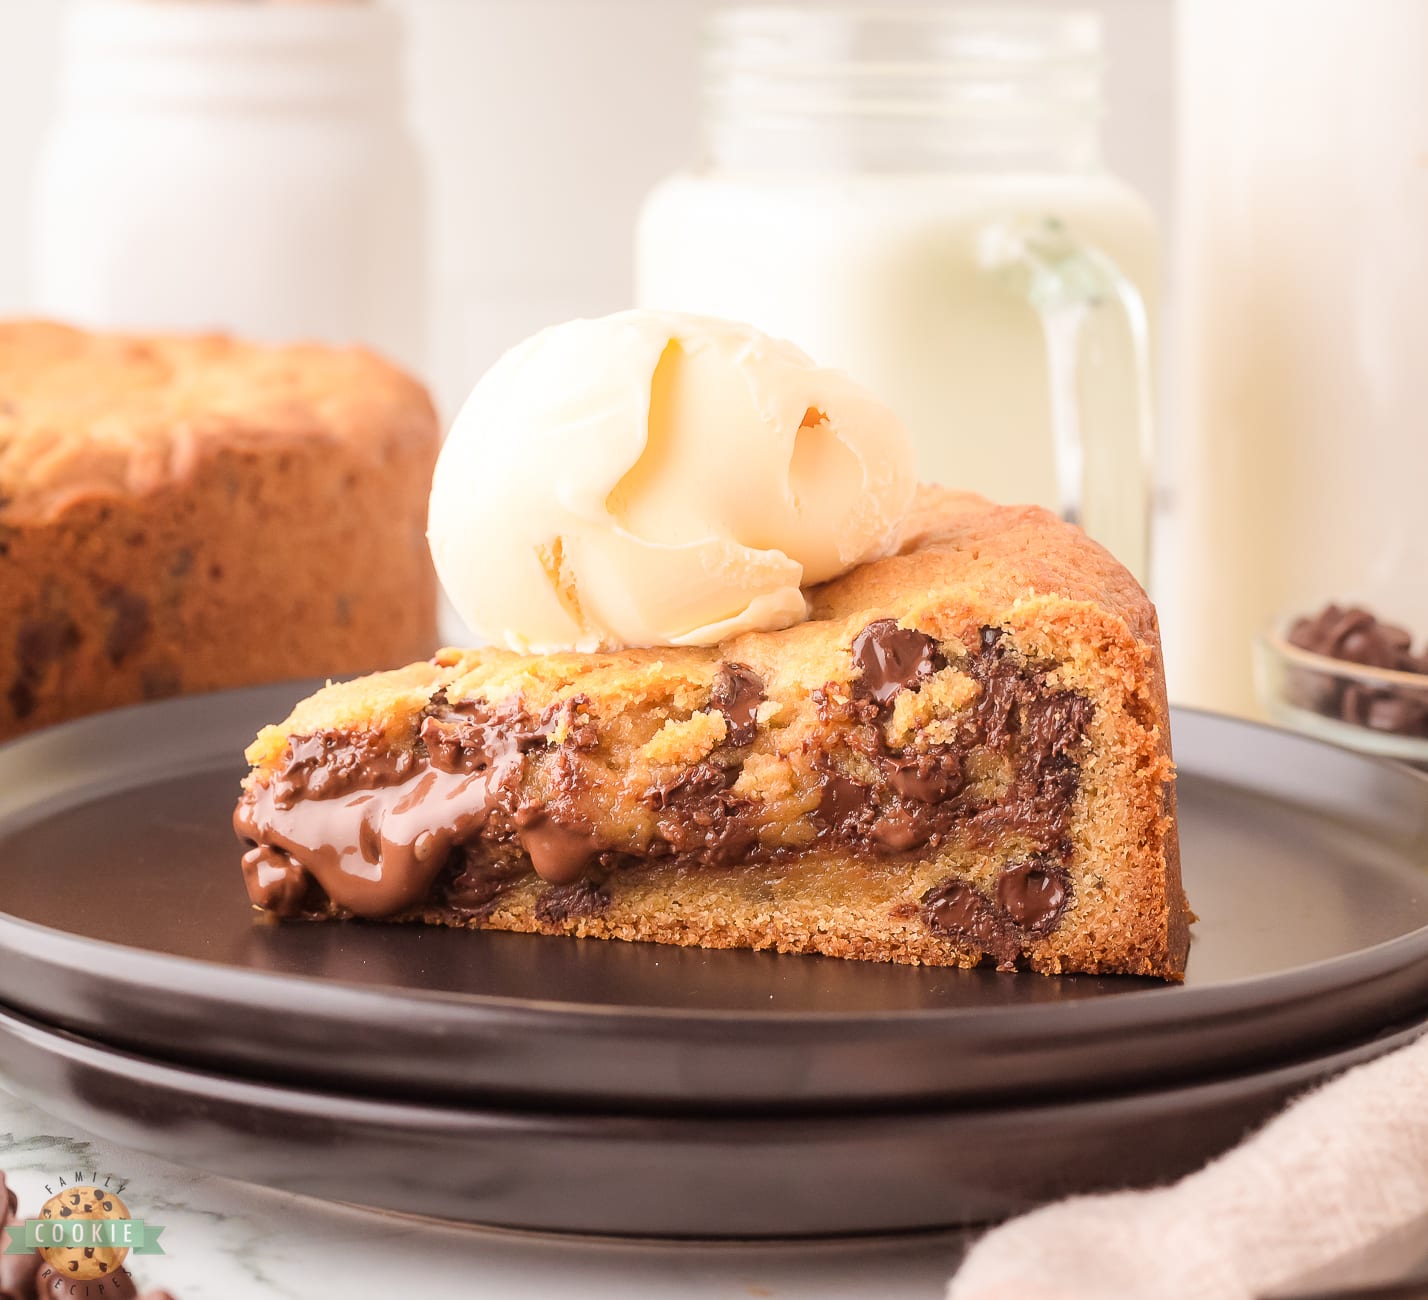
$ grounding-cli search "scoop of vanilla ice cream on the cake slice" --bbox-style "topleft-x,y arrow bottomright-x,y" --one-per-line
427,311 -> 917,653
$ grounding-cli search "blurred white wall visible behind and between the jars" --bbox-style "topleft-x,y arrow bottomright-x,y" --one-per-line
0,0 -> 1174,413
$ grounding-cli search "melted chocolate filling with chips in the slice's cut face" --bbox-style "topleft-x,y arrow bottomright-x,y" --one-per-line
234,620 -> 1091,925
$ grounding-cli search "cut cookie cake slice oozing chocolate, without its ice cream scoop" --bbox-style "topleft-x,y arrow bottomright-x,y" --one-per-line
234,487 -> 1188,980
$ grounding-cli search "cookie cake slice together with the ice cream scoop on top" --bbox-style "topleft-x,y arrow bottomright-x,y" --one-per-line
234,313 -> 1188,979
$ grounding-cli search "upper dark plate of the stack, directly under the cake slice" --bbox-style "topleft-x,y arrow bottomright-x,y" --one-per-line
0,684 -> 1428,1113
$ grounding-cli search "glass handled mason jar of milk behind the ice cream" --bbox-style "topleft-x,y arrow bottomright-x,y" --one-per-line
635,6 -> 1157,579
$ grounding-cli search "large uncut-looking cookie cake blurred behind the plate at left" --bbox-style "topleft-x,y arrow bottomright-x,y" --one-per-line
0,321 -> 438,740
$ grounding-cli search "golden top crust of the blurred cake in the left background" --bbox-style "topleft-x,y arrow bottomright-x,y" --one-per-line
0,321 -> 437,524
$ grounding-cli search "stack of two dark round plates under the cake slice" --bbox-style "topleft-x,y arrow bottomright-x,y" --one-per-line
0,684 -> 1428,1237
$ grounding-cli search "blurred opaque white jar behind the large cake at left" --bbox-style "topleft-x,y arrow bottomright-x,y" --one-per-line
31,0 -> 427,371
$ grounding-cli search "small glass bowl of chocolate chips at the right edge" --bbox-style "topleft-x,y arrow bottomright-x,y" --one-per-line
1255,601 -> 1428,766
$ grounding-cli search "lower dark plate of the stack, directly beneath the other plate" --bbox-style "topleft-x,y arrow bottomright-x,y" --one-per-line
0,1013 -> 1422,1237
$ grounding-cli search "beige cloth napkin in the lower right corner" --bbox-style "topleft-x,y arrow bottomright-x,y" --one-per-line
948,1037 -> 1428,1300
